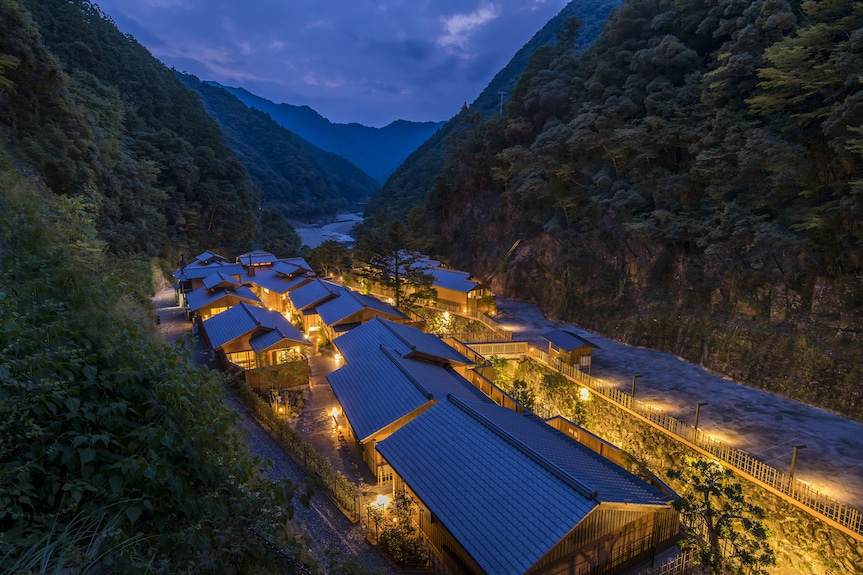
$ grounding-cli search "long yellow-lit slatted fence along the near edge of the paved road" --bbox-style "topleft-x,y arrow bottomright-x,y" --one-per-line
520,347 -> 863,541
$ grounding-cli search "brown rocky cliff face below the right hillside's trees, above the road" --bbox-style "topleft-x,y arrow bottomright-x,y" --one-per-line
443,205 -> 863,420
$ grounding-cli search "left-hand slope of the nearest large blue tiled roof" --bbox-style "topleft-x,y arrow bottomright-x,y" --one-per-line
377,396 -> 598,575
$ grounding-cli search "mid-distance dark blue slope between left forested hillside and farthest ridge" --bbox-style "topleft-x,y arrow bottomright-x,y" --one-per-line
177,72 -> 379,218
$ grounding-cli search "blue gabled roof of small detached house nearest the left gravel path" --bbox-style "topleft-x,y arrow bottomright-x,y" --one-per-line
202,303 -> 309,352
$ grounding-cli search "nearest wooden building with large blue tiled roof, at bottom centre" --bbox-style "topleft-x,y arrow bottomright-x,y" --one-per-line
377,395 -> 679,575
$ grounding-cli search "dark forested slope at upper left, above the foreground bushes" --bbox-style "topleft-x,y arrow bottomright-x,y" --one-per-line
0,0 -> 258,261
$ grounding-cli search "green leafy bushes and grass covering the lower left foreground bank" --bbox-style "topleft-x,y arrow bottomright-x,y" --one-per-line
0,161 -> 307,573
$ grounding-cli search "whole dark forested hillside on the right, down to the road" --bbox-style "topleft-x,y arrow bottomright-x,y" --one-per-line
417,0 -> 863,418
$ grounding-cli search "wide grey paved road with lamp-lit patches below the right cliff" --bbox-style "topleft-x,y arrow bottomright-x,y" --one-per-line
498,298 -> 863,510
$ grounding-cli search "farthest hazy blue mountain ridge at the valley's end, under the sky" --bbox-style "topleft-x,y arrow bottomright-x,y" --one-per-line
209,82 -> 444,183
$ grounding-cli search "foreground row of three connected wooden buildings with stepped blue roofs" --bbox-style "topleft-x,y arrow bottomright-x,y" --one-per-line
328,319 -> 678,575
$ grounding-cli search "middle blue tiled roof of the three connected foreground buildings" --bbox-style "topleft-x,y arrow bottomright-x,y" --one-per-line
327,344 -> 491,441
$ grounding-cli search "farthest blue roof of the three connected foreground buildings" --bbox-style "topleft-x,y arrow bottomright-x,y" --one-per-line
333,317 -> 471,365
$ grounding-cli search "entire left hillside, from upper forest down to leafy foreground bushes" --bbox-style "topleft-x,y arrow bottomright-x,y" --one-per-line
0,0 -> 328,574
